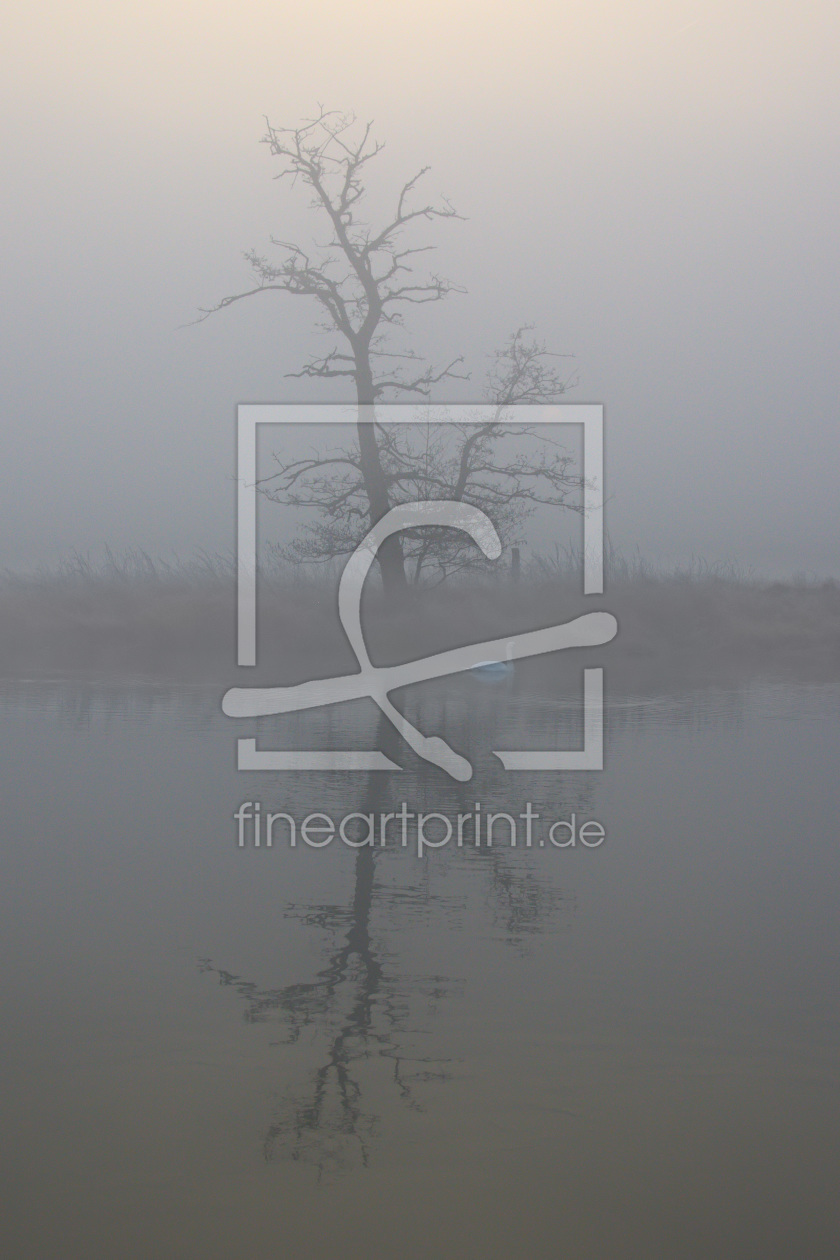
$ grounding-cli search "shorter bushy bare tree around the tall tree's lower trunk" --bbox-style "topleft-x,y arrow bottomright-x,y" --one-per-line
261,326 -> 582,583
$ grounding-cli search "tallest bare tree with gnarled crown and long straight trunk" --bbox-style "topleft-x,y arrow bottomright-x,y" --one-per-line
201,110 -> 463,591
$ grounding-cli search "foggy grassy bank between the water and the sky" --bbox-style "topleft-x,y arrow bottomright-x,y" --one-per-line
0,553 -> 840,685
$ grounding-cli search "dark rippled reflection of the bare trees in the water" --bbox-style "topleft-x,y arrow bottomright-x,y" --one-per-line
200,718 -> 589,1177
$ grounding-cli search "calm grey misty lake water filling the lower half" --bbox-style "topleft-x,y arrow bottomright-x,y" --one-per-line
0,675 -> 840,1260
